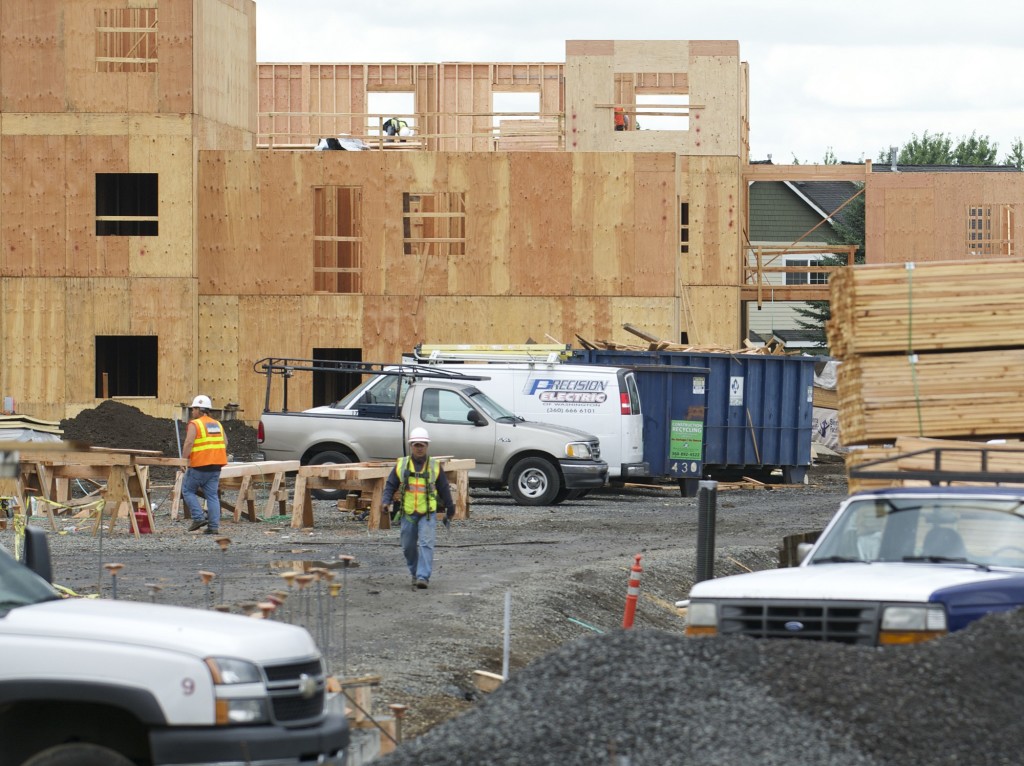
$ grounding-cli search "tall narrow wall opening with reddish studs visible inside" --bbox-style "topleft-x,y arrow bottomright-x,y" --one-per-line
313,186 -> 362,295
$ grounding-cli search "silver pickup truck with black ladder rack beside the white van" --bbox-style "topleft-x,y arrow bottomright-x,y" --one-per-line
255,358 -> 608,505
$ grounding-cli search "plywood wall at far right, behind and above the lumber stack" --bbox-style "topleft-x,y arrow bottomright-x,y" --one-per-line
865,172 -> 1024,263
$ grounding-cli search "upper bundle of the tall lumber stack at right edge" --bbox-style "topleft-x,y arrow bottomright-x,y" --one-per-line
826,253 -> 1024,358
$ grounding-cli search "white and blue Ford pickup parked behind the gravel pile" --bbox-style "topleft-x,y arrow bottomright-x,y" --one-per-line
679,449 -> 1024,645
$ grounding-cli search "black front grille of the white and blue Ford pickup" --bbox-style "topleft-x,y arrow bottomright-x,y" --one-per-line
719,601 -> 879,646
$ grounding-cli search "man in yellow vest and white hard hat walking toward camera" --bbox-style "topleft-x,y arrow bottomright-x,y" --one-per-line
382,428 -> 455,589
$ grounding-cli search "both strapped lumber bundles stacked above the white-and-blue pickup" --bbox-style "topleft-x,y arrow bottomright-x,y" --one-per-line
826,259 -> 1024,445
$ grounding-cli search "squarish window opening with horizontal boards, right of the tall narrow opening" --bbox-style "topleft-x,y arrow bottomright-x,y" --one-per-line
401,192 -> 466,258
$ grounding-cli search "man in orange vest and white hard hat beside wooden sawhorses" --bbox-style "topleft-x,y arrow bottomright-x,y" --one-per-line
181,393 -> 227,535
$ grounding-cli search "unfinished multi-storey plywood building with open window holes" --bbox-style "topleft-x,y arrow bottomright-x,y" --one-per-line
0,0 -> 1024,420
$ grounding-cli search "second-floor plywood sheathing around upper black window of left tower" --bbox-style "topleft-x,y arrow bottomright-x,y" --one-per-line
0,115 -> 194,276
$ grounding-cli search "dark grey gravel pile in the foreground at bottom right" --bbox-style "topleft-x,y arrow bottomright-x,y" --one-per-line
375,612 -> 1024,766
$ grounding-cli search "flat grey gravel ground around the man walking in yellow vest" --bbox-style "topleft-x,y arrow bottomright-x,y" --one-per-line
12,454 -> 846,737
